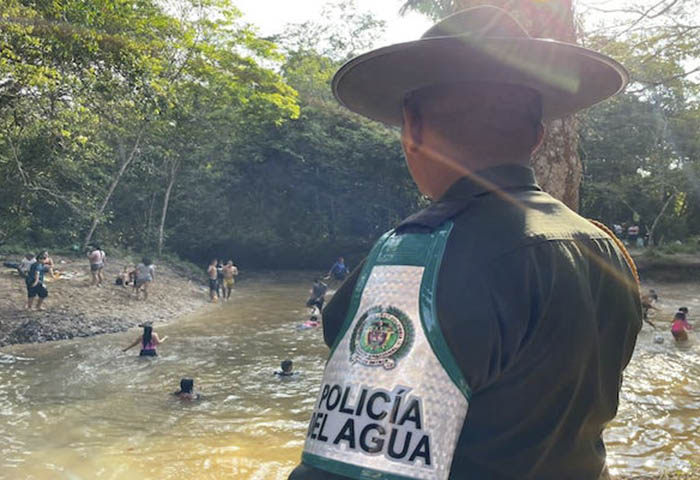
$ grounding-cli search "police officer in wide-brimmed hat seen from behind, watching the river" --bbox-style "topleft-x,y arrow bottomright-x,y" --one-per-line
289,6 -> 641,480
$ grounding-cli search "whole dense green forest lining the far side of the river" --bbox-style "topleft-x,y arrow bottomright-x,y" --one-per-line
0,0 -> 700,268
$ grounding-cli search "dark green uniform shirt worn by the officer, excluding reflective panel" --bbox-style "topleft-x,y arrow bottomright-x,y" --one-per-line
289,165 -> 642,480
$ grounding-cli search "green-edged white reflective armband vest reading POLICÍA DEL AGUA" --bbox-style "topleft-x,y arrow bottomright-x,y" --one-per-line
302,222 -> 471,480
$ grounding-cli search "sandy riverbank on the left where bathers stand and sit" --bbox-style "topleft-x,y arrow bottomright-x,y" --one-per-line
0,256 -> 207,346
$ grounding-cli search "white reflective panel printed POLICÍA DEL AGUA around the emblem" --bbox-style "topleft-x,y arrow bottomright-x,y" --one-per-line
304,265 -> 468,480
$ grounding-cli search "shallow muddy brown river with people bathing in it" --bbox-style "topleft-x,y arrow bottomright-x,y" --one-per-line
0,273 -> 700,480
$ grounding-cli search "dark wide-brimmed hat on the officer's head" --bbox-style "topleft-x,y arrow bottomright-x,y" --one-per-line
333,6 -> 628,125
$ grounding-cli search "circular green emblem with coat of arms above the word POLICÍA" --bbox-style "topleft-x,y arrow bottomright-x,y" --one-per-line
350,306 -> 413,370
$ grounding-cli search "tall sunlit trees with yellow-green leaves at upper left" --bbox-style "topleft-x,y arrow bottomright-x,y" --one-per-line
0,0 -> 298,252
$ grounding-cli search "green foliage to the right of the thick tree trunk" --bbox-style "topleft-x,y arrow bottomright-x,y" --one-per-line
579,16 -> 700,244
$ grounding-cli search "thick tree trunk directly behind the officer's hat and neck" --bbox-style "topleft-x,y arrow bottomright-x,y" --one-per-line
401,0 -> 582,210
